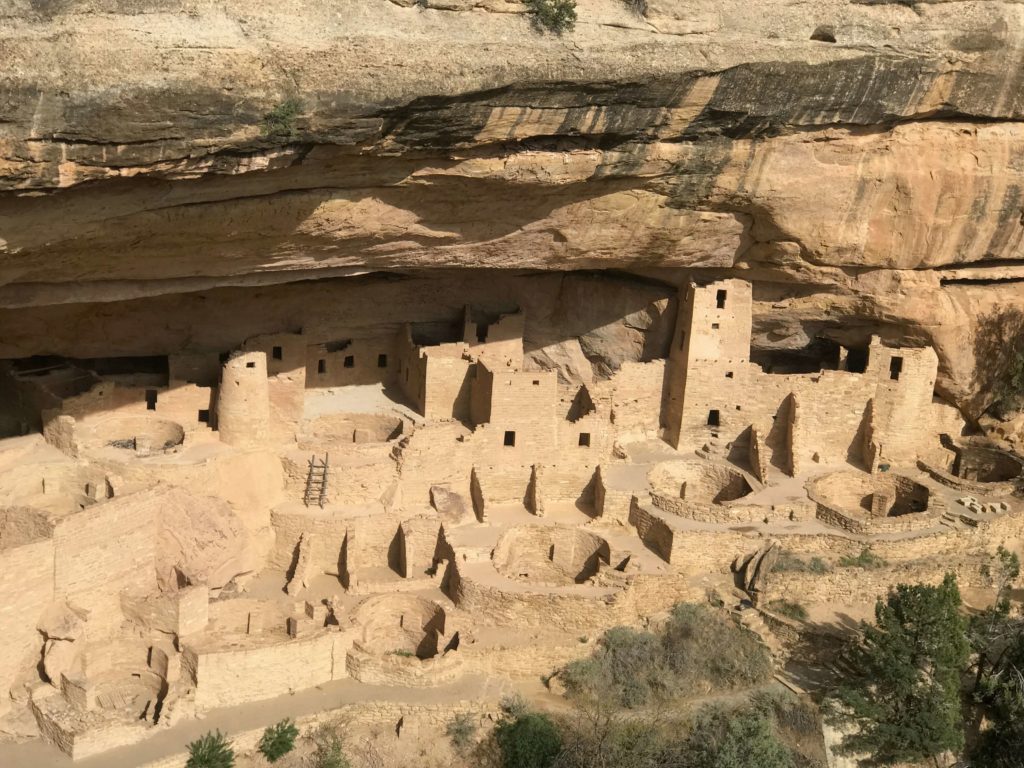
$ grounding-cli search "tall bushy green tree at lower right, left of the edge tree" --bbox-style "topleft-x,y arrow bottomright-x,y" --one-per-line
830,574 -> 969,765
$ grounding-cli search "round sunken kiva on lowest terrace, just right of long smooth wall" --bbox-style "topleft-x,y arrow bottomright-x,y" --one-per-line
353,594 -> 446,658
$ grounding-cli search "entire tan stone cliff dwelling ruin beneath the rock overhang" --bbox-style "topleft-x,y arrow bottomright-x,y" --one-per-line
0,279 -> 1022,759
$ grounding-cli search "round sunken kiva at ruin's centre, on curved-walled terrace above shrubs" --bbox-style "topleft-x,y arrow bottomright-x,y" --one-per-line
494,525 -> 609,586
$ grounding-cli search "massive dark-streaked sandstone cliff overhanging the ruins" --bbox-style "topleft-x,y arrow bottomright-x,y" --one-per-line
0,0 -> 1024,417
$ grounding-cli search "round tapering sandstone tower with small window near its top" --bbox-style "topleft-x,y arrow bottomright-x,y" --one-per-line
217,352 -> 270,447
